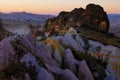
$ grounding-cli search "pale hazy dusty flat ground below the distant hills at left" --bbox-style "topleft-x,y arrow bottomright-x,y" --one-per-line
2,20 -> 30,34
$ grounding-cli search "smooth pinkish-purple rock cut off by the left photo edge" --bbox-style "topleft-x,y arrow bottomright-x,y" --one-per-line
0,37 -> 15,71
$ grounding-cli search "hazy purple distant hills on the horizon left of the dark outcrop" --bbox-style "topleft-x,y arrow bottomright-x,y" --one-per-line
0,12 -> 54,24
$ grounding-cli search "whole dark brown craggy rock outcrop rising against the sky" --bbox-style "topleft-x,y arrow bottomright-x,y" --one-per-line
45,4 -> 109,32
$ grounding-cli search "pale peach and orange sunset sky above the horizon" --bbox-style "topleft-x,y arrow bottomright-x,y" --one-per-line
0,0 -> 120,15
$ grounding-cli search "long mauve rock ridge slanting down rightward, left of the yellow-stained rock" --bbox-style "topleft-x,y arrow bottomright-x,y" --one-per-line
16,35 -> 59,67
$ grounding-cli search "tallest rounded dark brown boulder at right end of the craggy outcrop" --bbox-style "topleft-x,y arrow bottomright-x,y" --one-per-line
84,4 -> 109,32
